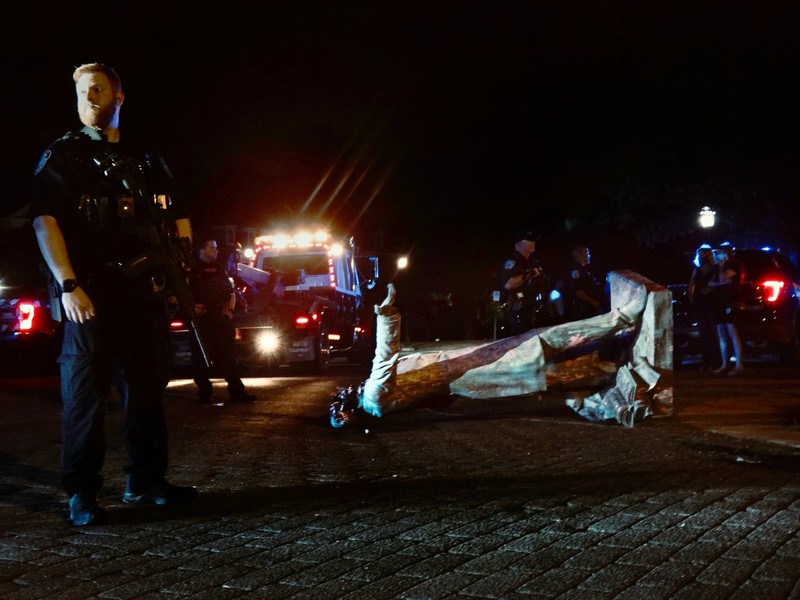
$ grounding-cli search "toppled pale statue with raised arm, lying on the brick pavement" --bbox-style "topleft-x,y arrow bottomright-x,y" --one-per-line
330,271 -> 672,428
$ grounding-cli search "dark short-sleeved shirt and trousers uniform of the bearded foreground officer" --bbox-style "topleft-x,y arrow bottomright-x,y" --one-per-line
30,127 -> 186,502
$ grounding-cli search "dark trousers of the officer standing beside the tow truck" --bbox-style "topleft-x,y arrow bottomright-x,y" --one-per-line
192,314 -> 244,398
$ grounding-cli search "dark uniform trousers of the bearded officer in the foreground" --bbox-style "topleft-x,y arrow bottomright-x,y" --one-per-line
58,307 -> 168,495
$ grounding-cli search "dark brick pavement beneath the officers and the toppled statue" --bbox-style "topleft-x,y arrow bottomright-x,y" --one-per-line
0,369 -> 800,599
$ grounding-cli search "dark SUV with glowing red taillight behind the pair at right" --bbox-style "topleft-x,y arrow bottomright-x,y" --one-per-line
667,248 -> 800,366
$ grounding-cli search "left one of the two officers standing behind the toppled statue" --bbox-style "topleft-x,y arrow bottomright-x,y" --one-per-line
501,229 -> 546,335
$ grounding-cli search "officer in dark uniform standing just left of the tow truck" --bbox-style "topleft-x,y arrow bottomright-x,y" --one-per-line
189,238 -> 256,404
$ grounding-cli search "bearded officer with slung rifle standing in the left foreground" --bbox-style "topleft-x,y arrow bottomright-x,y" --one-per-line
30,63 -> 197,526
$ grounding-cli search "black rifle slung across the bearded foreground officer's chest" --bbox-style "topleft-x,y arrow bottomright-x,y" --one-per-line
92,151 -> 211,367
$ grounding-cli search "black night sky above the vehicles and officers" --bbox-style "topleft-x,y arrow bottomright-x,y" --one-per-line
0,0 -> 800,290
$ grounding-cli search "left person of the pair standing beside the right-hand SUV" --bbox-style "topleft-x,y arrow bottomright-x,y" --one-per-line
686,244 -> 720,371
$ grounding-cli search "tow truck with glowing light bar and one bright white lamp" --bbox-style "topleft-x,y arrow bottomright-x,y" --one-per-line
167,229 -> 379,373
